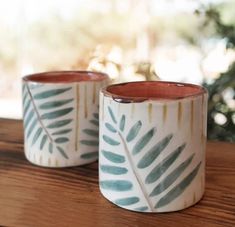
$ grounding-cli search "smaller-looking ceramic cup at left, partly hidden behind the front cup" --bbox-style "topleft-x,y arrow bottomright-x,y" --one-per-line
23,71 -> 108,167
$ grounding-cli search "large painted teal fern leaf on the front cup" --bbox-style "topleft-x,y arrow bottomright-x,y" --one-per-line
99,106 -> 200,212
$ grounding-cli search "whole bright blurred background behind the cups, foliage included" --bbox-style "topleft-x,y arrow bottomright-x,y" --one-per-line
0,0 -> 235,142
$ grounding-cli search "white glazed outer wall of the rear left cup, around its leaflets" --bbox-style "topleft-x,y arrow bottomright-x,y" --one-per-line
23,72 -> 108,167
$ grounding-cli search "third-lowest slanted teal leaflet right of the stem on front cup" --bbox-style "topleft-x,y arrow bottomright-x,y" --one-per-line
145,144 -> 185,184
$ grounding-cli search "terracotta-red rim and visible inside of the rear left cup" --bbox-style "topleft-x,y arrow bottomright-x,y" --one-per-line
23,71 -> 108,84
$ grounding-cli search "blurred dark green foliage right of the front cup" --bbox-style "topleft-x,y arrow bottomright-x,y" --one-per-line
199,6 -> 235,142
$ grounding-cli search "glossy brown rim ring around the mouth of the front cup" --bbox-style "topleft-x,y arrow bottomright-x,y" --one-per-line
101,81 -> 208,103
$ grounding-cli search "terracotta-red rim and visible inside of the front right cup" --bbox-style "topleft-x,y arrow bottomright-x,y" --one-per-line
102,81 -> 207,103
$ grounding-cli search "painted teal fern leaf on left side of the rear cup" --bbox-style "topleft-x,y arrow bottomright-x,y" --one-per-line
23,84 -> 73,159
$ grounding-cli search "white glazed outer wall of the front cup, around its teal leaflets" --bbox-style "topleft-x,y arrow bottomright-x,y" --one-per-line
99,83 -> 207,212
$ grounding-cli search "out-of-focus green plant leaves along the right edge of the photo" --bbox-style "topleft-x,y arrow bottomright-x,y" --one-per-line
195,6 -> 235,142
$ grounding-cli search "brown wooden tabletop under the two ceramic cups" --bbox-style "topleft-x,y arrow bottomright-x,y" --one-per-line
0,119 -> 235,227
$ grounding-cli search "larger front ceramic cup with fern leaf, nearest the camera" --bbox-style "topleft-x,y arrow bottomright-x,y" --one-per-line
99,81 -> 207,212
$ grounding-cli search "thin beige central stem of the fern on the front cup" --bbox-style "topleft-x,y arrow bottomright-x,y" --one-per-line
118,132 -> 154,212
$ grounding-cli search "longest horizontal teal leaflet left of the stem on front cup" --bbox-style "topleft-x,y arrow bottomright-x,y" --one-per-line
100,180 -> 133,192
